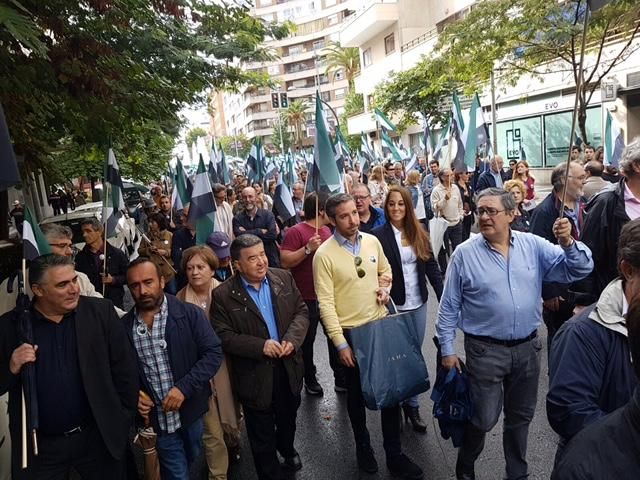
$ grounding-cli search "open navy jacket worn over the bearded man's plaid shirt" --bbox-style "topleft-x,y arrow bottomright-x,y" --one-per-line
123,295 -> 222,432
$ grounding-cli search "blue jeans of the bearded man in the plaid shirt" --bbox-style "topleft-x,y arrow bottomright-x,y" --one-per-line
156,418 -> 203,480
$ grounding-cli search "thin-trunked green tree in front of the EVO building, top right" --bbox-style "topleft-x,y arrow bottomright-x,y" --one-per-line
436,0 -> 640,141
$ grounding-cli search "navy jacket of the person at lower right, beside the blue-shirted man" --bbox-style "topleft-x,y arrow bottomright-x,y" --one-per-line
547,304 -> 637,439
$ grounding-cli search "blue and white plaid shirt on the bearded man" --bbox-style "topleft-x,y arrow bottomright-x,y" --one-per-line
133,297 -> 180,433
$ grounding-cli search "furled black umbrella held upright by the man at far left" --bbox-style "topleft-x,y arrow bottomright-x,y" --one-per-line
15,270 -> 39,468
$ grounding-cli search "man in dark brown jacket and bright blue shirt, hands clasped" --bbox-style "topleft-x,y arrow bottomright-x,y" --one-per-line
211,235 -> 309,480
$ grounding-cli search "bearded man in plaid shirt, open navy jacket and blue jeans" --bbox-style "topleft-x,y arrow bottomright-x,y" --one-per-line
124,257 -> 222,479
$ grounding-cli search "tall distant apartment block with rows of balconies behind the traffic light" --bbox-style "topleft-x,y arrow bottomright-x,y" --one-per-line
212,0 -> 354,148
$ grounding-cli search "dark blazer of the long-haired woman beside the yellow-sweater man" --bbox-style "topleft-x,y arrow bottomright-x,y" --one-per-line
371,222 -> 442,305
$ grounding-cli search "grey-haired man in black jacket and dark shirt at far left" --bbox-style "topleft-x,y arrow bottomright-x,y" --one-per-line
0,255 -> 138,480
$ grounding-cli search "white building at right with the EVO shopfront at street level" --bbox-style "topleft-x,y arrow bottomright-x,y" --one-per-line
340,0 -> 640,176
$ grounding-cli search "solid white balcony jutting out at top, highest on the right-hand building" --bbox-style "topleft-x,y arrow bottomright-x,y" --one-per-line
340,0 -> 399,47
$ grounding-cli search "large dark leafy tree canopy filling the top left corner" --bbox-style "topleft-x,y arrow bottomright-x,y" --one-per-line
0,0 -> 288,184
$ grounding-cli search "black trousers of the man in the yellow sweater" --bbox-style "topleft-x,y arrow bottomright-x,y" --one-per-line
344,330 -> 402,458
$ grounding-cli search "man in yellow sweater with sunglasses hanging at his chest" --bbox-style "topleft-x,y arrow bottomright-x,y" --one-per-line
313,193 -> 422,479
